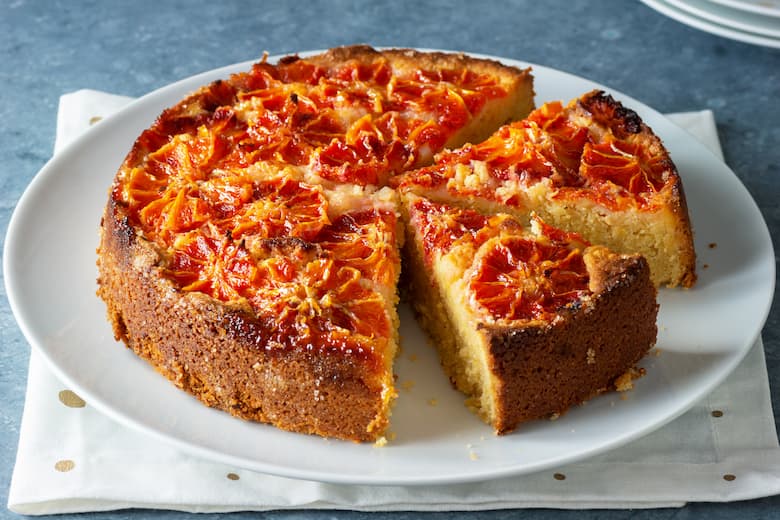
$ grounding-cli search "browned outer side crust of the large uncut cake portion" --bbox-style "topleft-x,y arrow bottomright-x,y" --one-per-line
98,202 -> 394,441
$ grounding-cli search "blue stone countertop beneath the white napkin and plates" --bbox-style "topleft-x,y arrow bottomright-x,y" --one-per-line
0,0 -> 780,519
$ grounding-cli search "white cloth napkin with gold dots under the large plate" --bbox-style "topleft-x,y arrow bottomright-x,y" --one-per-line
8,90 -> 780,514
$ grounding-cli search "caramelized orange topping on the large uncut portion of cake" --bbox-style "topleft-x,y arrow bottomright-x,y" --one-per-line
112,51 -> 506,358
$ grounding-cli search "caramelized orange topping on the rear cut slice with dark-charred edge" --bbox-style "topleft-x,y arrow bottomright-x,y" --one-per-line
401,92 -> 674,209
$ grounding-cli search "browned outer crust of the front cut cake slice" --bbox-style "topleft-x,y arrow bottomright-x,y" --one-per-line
480,248 -> 658,434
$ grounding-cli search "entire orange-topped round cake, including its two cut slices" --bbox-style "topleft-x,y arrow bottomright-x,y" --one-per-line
97,46 -> 695,443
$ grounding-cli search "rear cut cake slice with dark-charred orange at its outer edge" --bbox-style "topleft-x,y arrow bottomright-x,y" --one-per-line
397,87 -> 696,287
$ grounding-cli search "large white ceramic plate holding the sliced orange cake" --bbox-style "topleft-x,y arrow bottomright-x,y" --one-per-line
4,50 -> 775,485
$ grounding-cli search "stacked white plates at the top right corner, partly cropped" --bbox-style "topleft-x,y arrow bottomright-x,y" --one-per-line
642,0 -> 780,48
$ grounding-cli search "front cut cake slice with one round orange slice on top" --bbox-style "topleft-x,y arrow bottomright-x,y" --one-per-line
402,193 -> 658,434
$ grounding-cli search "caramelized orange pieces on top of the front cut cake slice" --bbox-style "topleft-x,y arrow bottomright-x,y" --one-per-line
411,199 -> 589,320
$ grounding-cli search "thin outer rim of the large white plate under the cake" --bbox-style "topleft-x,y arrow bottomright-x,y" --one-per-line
3,49 -> 775,485
